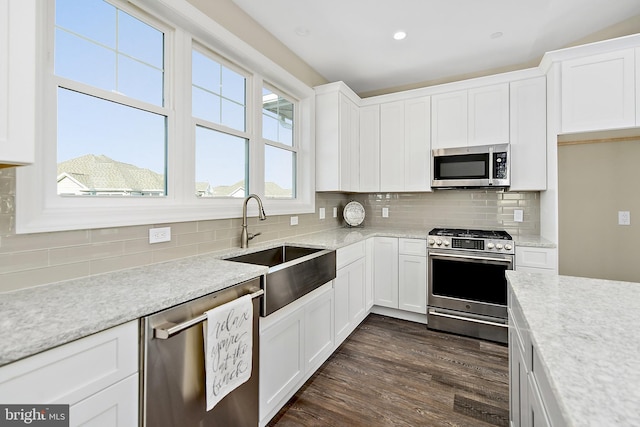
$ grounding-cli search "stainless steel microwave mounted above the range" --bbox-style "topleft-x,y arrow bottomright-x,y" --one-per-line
431,144 -> 511,188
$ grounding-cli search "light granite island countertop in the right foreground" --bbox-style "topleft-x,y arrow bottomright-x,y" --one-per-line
507,271 -> 640,427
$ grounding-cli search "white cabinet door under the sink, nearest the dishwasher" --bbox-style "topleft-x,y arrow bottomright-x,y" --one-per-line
260,309 -> 305,419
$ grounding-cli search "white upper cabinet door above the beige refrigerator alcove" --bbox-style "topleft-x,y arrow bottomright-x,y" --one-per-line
561,49 -> 636,132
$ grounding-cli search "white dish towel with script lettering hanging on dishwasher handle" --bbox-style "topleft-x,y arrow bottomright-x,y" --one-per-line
203,295 -> 253,411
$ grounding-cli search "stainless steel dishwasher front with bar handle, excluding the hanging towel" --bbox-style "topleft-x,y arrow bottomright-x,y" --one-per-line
140,278 -> 263,427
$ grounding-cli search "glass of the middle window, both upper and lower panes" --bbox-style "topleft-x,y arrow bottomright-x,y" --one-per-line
191,49 -> 249,198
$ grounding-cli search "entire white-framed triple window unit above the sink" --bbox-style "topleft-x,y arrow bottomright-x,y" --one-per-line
16,0 -> 315,233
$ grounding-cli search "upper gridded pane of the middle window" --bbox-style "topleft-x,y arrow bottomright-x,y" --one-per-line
191,50 -> 246,131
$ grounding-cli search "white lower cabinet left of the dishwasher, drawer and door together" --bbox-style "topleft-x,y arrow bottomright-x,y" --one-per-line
0,321 -> 139,427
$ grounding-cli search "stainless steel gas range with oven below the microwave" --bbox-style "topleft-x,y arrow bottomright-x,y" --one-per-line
427,228 -> 515,343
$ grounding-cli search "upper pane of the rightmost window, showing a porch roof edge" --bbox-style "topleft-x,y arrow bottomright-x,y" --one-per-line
262,89 -> 293,147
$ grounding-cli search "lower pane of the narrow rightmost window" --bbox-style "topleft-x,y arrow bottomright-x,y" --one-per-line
264,145 -> 296,199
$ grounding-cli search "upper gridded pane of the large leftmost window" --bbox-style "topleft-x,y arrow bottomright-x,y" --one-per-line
55,0 -> 164,105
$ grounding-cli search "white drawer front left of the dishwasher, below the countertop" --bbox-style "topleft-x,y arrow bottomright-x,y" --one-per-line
0,320 -> 138,405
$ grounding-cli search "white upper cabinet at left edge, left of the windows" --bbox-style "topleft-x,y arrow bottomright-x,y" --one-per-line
0,0 -> 36,167
